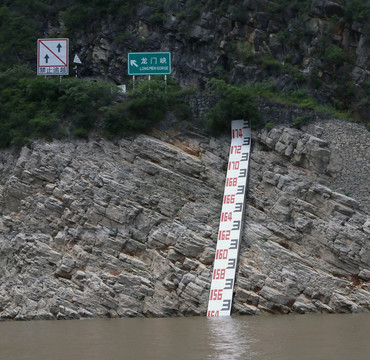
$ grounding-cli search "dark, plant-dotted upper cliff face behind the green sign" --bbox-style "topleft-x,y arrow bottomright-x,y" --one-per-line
65,0 -> 370,121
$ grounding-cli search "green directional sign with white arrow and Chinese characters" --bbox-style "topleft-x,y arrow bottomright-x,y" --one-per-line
127,52 -> 171,75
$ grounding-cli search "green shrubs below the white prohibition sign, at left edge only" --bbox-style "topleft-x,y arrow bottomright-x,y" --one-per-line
0,66 -> 117,147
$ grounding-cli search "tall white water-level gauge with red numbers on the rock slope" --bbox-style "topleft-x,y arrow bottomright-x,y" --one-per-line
207,120 -> 251,317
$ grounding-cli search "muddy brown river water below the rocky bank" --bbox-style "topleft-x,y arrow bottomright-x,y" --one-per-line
0,313 -> 370,360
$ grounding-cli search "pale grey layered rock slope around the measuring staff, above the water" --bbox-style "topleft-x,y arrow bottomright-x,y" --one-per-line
0,116 -> 370,320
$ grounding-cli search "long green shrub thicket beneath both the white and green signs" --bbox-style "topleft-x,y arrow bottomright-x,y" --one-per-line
0,66 -> 192,147
